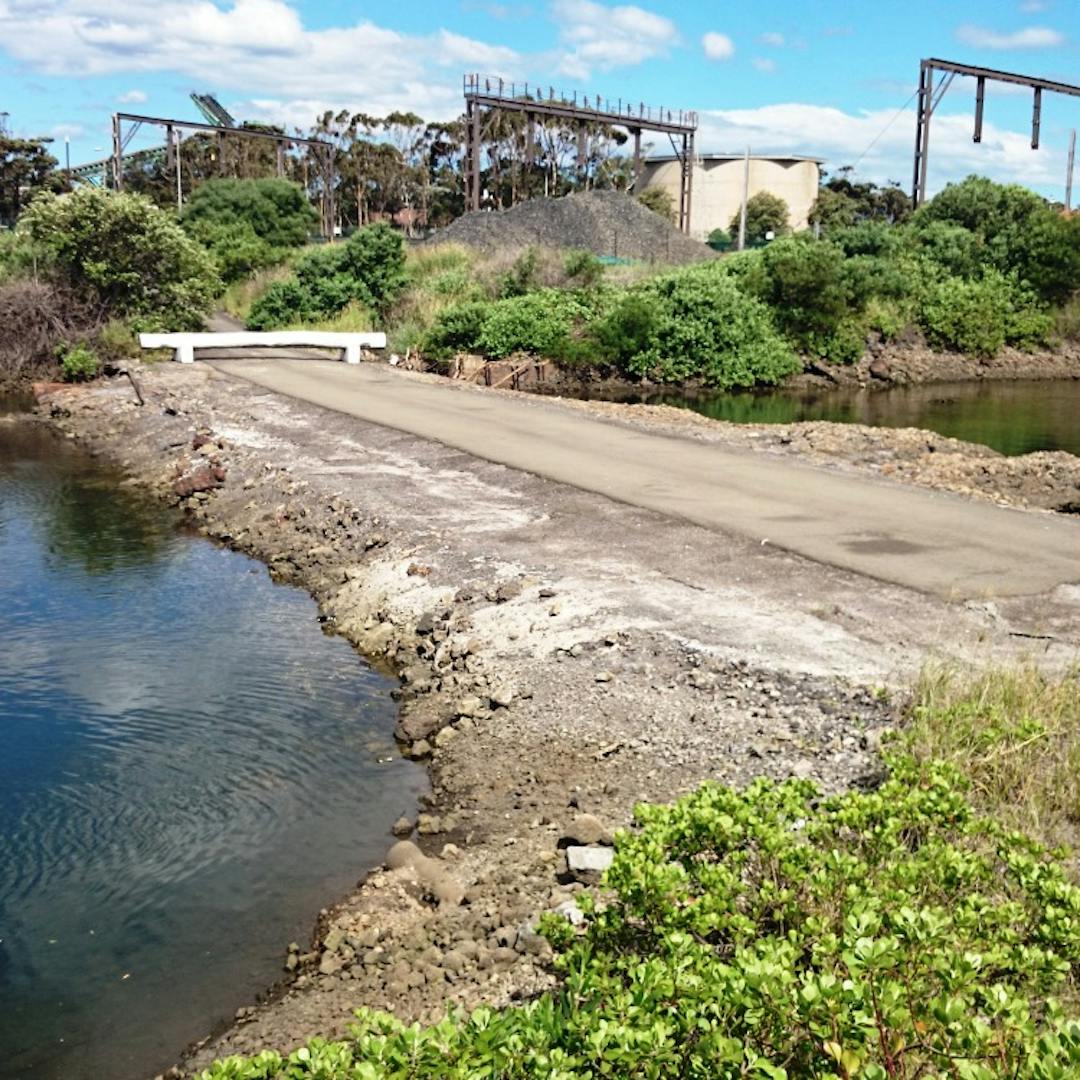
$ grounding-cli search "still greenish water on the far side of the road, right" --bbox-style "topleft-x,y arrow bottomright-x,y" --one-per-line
587,379 -> 1080,455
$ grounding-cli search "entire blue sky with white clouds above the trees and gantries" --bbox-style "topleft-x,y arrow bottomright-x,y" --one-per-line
0,0 -> 1080,198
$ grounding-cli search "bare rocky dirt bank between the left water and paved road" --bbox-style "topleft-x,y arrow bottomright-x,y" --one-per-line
29,365 -> 1080,1068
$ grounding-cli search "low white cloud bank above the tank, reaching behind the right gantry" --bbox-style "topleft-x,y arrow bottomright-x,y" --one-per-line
698,103 -> 1064,191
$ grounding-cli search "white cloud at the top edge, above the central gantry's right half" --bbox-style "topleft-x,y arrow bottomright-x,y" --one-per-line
551,0 -> 679,79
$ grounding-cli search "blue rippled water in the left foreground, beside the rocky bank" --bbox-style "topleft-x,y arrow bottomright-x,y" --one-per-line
0,416 -> 423,1080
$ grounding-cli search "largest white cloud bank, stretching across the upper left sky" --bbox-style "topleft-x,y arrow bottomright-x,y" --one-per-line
0,0 -> 518,126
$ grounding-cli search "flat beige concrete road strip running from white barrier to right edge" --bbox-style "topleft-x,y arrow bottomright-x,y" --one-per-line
213,359 -> 1080,599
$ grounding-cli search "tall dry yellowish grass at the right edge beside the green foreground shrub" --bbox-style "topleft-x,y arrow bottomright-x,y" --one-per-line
903,665 -> 1080,852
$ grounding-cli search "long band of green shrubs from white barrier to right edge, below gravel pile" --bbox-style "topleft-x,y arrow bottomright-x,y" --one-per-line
234,175 -> 1080,388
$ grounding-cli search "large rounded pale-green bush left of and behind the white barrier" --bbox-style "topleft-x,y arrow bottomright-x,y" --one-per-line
19,187 -> 219,330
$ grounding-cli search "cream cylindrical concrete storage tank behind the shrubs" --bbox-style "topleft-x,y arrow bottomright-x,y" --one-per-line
642,158 -> 821,240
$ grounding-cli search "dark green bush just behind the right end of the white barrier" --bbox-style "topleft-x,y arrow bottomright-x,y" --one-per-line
247,225 -> 406,330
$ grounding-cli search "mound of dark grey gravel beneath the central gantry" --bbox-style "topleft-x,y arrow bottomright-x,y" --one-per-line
433,191 -> 714,264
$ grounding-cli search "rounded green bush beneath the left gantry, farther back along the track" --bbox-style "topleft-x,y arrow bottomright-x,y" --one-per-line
181,179 -> 318,282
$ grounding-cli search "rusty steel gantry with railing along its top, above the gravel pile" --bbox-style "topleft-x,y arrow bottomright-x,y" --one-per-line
464,75 -> 698,232
